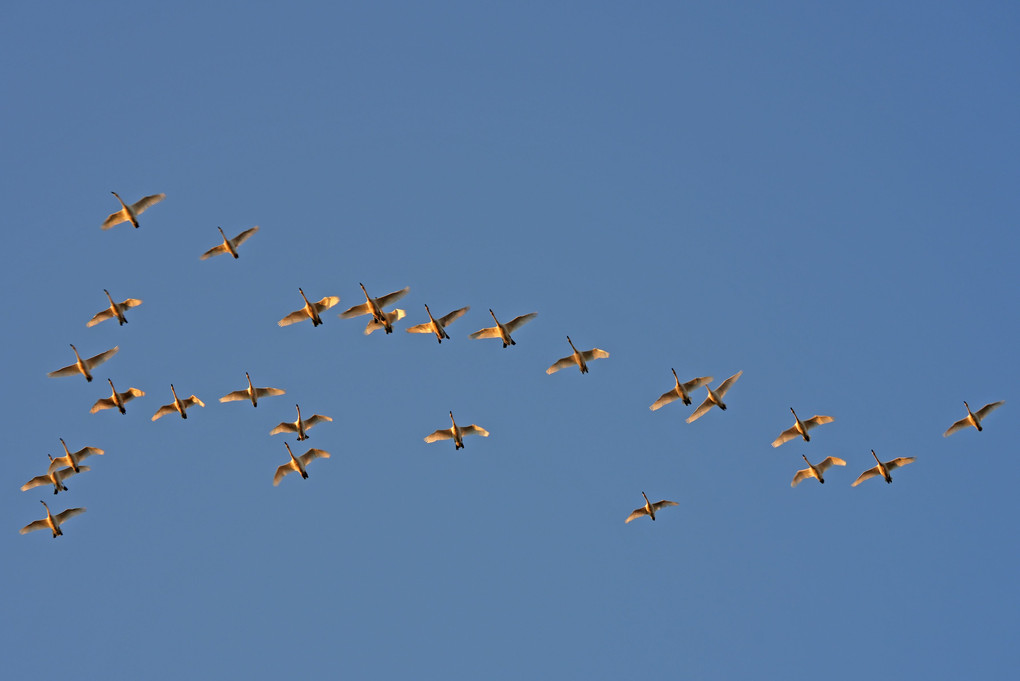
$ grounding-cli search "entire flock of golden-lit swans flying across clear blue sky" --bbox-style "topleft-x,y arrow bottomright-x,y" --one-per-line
20,192 -> 1005,537
